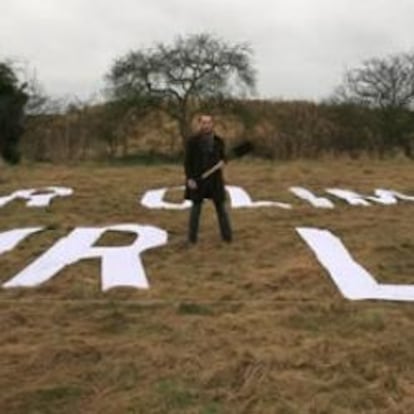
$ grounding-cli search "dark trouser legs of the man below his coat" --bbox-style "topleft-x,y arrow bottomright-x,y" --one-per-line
188,200 -> 233,243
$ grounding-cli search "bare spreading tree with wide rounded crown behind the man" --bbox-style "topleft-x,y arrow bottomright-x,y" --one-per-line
106,34 -> 255,147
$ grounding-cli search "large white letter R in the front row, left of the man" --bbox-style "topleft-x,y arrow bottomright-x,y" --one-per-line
3,224 -> 168,291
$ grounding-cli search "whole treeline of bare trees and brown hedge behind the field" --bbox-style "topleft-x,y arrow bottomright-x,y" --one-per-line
0,34 -> 414,163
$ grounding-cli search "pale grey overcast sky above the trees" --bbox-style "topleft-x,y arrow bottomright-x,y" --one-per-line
0,0 -> 414,100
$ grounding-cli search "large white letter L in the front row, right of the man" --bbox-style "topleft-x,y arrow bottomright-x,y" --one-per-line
296,227 -> 414,302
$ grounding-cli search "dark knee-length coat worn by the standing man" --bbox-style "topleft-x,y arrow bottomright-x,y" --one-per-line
184,134 -> 226,201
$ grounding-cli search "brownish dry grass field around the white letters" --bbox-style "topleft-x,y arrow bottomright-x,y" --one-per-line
0,159 -> 414,414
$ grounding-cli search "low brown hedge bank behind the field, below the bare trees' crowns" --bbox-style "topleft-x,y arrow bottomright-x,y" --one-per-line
21,100 -> 414,162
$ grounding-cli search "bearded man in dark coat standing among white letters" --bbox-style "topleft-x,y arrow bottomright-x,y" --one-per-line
184,115 -> 232,244
